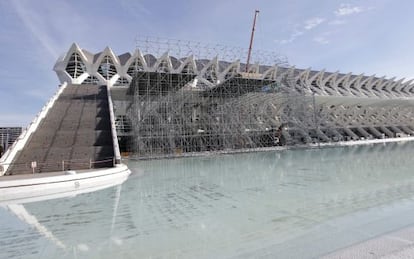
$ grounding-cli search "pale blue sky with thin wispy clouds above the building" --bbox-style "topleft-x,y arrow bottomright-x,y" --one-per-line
0,0 -> 414,126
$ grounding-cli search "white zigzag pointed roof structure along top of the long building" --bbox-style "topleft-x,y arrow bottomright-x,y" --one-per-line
54,43 -> 414,98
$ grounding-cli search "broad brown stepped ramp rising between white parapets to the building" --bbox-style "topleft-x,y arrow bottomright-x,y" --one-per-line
6,85 -> 114,175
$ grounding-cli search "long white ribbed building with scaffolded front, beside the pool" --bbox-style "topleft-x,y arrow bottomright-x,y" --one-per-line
54,44 -> 414,156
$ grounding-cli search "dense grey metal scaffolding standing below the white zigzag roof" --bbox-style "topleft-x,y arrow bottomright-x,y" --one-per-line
128,67 -> 326,158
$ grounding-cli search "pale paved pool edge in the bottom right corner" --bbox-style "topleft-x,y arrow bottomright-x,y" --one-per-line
322,226 -> 414,259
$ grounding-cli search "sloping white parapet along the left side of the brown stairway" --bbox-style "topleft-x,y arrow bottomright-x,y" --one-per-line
0,82 -> 67,176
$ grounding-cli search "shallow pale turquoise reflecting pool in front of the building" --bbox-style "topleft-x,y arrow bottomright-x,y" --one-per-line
0,142 -> 414,258
